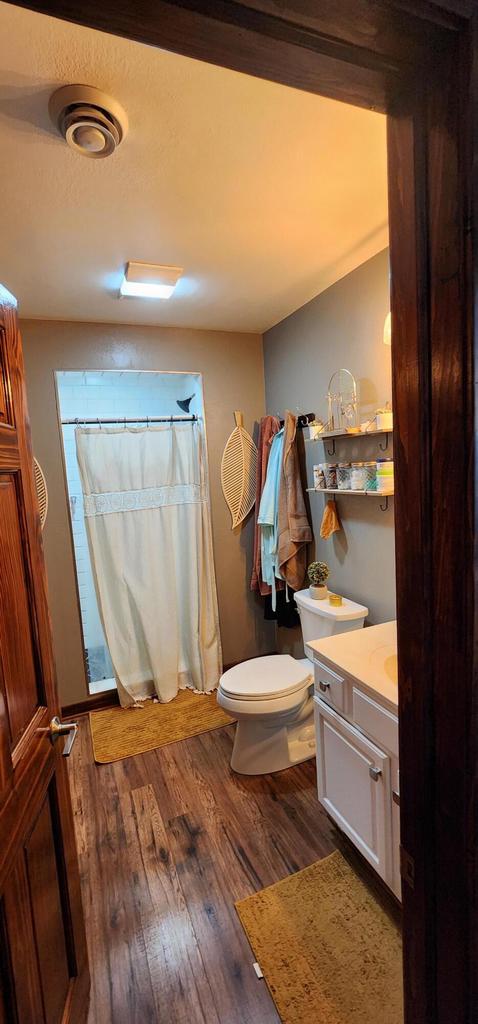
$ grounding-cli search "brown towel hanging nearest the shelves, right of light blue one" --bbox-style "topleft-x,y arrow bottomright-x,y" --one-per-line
277,412 -> 312,590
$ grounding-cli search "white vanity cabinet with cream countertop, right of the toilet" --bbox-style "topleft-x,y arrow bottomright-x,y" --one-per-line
310,623 -> 401,898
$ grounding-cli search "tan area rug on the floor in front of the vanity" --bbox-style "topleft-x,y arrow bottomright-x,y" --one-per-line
235,853 -> 403,1024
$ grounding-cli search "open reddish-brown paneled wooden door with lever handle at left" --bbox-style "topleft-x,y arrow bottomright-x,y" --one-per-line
0,286 -> 89,1024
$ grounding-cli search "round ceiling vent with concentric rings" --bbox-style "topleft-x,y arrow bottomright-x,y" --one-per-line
48,85 -> 128,160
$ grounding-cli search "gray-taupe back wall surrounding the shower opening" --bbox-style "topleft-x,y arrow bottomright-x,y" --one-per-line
20,321 -> 274,703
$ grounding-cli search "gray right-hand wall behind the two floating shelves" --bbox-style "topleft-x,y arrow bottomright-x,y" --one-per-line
264,250 -> 395,630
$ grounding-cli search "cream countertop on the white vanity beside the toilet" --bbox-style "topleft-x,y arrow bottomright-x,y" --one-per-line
307,620 -> 398,714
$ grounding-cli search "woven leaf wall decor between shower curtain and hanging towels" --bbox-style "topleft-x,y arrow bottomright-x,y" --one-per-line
221,413 -> 257,529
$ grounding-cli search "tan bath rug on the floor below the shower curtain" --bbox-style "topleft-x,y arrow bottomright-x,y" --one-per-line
90,690 -> 233,764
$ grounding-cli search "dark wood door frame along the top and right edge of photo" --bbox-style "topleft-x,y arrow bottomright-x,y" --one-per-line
4,0 -> 478,1024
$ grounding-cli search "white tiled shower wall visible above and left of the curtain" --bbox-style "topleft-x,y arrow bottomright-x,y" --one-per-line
56,371 -> 203,691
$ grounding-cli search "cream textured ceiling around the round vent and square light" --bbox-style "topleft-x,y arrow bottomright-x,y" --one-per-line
0,3 -> 388,332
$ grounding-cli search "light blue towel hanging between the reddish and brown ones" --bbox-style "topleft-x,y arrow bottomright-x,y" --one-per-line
257,429 -> 284,608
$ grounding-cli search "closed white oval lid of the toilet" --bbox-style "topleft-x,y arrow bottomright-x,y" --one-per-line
220,654 -> 311,700
